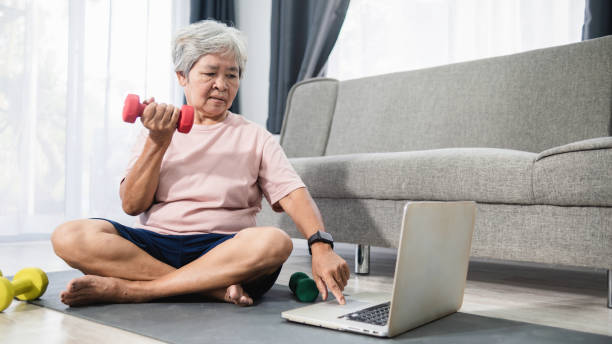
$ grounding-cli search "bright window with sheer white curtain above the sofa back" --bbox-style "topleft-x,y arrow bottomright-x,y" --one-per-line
327,0 -> 585,80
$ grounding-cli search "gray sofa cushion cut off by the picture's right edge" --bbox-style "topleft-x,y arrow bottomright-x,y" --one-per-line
533,137 -> 612,207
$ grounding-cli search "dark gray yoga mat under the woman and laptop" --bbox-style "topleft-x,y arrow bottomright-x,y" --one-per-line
32,270 -> 612,344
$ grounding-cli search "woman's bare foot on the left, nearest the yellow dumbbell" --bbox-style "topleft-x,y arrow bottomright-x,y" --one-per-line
60,275 -> 145,306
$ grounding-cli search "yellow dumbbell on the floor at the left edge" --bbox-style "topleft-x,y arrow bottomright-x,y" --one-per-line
0,268 -> 49,312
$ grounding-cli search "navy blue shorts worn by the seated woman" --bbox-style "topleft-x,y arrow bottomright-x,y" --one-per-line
94,218 -> 281,299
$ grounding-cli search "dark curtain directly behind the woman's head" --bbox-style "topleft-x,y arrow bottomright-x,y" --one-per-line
189,0 -> 240,114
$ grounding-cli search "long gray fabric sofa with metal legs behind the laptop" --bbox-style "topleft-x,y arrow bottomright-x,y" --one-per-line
258,36 -> 612,306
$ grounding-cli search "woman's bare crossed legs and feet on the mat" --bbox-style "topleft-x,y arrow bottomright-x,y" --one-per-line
51,220 -> 293,306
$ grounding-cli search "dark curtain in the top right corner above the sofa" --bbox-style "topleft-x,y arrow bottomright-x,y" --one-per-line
582,0 -> 612,41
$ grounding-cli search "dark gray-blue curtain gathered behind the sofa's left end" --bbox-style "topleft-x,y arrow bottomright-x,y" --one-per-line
267,0 -> 349,134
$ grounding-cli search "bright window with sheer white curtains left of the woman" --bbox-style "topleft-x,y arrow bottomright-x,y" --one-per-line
0,0 -> 189,235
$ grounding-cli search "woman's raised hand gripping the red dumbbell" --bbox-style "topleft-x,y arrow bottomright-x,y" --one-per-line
140,98 -> 180,144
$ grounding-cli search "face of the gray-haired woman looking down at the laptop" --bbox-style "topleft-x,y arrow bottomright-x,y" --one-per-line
176,54 -> 240,124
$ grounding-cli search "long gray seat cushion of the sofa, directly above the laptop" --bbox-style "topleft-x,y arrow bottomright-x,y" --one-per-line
290,148 -> 537,204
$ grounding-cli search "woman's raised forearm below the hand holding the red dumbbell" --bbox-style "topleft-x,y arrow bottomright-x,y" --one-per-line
120,137 -> 170,216
